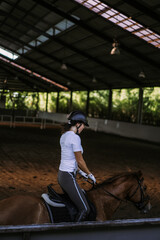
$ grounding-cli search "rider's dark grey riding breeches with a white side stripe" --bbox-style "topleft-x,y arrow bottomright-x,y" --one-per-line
58,170 -> 90,215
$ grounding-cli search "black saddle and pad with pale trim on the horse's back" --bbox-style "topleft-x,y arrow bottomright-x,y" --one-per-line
41,184 -> 96,223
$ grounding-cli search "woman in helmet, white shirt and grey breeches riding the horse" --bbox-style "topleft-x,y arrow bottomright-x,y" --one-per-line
58,111 -> 96,222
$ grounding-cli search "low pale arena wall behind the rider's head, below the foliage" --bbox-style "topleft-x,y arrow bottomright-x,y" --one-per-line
39,112 -> 160,143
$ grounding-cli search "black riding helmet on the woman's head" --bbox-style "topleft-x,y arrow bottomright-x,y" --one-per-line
68,111 -> 89,127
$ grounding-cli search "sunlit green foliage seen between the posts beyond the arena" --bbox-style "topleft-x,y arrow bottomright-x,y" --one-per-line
2,87 -> 160,126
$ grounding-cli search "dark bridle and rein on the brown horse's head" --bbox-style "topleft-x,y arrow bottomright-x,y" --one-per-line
104,176 -> 149,210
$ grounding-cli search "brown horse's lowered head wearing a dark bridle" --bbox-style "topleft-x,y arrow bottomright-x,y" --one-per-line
127,171 -> 151,213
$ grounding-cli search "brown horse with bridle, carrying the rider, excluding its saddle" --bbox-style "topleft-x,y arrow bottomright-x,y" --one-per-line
0,171 -> 150,225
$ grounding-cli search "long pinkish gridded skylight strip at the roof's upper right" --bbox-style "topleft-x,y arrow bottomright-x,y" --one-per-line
74,0 -> 160,48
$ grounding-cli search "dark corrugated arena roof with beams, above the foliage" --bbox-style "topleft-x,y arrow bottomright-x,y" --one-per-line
0,0 -> 160,92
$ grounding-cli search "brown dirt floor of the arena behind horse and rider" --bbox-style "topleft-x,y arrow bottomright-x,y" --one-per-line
0,125 -> 160,219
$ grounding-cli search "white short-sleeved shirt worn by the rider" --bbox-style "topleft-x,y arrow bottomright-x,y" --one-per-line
59,131 -> 83,172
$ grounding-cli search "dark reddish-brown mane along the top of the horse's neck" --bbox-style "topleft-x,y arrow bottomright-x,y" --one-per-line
96,171 -> 142,188
